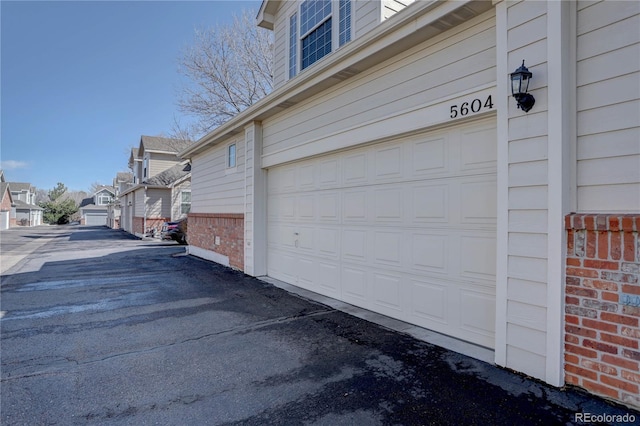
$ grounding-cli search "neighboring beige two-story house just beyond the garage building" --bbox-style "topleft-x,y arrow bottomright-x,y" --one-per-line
119,136 -> 191,236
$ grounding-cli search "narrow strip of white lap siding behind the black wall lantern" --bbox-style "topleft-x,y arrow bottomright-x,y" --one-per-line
505,2 -> 549,377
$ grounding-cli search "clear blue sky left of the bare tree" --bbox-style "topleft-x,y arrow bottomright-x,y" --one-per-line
0,0 -> 261,191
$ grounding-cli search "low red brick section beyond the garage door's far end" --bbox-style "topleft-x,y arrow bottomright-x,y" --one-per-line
187,213 -> 244,271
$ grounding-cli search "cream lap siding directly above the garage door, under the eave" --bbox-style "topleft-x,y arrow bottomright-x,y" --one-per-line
263,12 -> 495,160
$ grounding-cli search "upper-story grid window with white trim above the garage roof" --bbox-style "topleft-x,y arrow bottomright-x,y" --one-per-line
289,0 -> 351,78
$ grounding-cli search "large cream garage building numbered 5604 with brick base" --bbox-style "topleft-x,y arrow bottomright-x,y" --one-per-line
180,0 -> 640,407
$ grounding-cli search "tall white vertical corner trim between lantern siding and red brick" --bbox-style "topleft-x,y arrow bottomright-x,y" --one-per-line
545,2 -> 576,386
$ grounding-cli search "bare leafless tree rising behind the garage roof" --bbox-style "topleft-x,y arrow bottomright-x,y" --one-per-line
173,10 -> 273,140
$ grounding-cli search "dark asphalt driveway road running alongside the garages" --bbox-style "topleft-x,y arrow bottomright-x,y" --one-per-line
0,226 -> 640,425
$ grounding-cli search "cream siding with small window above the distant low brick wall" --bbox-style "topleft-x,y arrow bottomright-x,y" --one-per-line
191,139 -> 244,213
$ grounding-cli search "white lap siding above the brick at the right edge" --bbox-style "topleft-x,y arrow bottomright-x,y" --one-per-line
577,1 -> 640,212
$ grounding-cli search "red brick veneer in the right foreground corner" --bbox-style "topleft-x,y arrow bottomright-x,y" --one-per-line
565,214 -> 640,408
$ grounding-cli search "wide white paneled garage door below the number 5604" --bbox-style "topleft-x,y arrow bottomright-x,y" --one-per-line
268,120 -> 496,347
